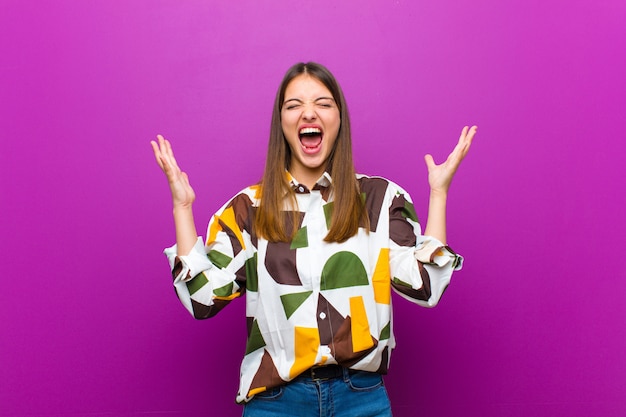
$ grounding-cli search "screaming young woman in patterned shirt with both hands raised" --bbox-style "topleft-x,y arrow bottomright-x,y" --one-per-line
152,63 -> 476,417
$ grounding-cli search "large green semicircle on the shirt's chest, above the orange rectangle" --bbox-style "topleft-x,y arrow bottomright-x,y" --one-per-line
320,251 -> 369,290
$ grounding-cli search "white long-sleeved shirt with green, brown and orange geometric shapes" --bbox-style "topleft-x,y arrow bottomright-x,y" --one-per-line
165,173 -> 462,403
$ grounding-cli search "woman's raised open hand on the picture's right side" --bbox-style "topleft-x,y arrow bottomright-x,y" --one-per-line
424,126 -> 478,194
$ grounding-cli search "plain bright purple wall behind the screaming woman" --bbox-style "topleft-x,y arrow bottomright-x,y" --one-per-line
0,0 -> 626,417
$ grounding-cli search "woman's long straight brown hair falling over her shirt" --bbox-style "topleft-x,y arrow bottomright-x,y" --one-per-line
254,62 -> 369,242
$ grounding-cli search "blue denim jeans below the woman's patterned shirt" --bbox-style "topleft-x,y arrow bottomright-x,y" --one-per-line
243,369 -> 391,417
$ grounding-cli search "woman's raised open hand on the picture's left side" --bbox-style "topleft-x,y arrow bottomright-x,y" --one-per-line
150,135 -> 196,208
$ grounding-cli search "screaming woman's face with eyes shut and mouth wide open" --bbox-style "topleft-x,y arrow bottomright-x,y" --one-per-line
281,74 -> 341,188
